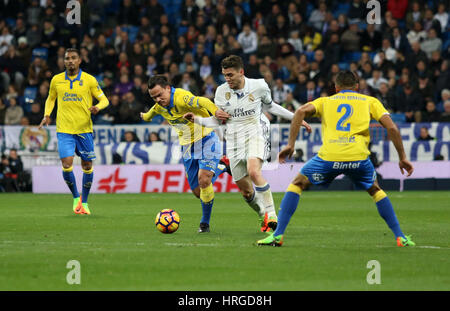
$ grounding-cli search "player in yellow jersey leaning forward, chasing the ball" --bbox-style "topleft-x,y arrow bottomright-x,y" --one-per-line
141,75 -> 229,233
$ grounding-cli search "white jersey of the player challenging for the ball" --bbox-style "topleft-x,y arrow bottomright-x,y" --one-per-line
214,78 -> 272,160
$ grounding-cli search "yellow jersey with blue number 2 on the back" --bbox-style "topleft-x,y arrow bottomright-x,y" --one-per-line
310,90 -> 389,161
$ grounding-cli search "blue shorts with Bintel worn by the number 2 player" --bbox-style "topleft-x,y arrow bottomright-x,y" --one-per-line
300,155 -> 377,190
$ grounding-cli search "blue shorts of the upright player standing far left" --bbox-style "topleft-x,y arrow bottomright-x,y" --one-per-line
56,133 -> 95,161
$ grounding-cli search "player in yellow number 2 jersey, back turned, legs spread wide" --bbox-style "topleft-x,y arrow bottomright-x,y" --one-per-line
257,70 -> 415,246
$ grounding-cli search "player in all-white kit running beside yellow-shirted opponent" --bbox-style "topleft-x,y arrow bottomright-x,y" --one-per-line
185,55 -> 311,232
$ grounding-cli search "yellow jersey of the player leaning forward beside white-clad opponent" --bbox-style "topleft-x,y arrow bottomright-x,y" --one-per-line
143,87 -> 218,145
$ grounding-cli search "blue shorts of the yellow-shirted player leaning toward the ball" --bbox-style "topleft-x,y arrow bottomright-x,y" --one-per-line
181,132 -> 222,190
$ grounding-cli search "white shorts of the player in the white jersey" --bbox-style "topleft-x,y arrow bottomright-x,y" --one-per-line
227,136 -> 270,181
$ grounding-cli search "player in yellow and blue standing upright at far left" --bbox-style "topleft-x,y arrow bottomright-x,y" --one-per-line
39,48 -> 109,215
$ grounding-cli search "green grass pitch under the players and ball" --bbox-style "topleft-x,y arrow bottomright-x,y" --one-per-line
0,192 -> 450,291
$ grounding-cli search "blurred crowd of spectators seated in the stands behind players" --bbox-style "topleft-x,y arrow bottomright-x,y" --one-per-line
0,0 -> 450,129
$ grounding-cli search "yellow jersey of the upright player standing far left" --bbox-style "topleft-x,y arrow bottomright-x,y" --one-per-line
44,69 -> 109,134
